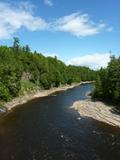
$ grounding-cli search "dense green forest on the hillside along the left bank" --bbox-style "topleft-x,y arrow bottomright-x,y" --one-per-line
0,38 -> 95,101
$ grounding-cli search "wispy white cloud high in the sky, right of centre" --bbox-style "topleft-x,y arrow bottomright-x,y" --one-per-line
51,12 -> 106,37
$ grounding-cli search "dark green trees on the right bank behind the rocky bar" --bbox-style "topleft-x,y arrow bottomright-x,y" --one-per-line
93,56 -> 120,104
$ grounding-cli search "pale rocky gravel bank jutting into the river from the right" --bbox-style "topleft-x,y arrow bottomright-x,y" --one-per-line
71,99 -> 120,127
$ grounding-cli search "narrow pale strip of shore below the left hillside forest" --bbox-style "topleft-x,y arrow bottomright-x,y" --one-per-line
1,81 -> 92,114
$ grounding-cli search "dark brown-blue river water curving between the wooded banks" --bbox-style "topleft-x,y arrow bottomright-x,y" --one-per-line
0,84 -> 120,160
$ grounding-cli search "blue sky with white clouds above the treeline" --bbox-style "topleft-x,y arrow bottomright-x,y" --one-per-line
0,0 -> 120,69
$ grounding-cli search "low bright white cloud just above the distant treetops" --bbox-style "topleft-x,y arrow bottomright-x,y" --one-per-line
67,53 -> 110,69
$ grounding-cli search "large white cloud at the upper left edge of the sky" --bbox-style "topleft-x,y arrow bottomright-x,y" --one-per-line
0,2 -> 48,39
